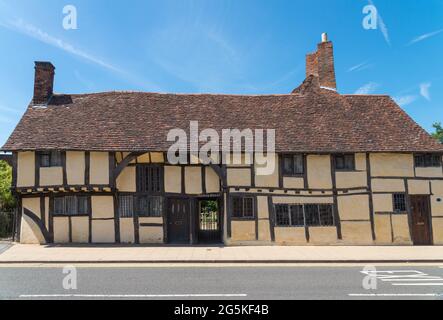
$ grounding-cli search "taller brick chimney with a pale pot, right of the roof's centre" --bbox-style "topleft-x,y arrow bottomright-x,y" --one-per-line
306,33 -> 337,90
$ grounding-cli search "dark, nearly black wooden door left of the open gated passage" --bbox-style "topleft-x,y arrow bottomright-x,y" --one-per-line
167,198 -> 191,244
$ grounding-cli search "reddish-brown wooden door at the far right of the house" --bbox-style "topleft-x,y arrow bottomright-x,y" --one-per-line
410,196 -> 432,246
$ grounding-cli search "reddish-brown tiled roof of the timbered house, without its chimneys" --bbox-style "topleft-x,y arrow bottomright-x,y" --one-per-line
2,76 -> 443,153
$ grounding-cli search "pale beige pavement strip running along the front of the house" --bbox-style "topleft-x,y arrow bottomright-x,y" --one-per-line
0,244 -> 443,264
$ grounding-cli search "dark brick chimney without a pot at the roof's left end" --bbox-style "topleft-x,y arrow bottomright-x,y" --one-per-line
32,61 -> 55,105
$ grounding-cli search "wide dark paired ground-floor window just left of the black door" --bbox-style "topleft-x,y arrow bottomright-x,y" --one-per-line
118,195 -> 163,218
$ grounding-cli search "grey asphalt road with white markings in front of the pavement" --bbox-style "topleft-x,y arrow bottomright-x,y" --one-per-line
0,265 -> 443,300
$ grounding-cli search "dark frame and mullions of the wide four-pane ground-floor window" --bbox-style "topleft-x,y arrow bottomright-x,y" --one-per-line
274,203 -> 337,228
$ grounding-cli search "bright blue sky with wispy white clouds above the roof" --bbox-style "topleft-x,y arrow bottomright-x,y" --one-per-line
0,0 -> 443,145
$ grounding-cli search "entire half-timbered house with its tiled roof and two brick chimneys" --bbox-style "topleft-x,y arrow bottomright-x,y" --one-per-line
2,35 -> 443,245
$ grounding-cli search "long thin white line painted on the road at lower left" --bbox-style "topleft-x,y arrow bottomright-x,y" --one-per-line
19,293 -> 248,298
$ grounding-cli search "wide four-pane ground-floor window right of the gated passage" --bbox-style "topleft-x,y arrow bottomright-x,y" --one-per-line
275,204 -> 335,227
